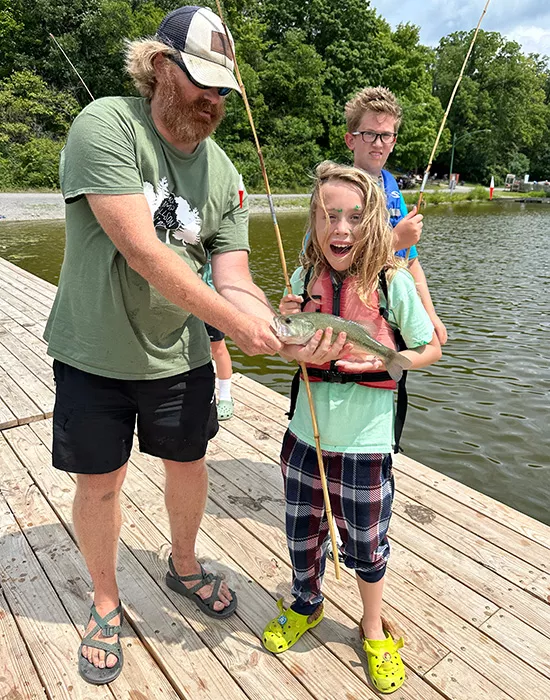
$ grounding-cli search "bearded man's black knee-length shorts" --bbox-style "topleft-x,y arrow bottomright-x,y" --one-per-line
52,360 -> 218,474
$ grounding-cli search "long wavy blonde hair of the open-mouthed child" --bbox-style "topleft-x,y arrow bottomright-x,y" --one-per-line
301,160 -> 402,305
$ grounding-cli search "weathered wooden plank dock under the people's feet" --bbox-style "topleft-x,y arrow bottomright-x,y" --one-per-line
0,259 -> 550,700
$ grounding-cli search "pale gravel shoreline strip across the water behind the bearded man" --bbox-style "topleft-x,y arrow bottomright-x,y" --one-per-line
0,192 -> 309,222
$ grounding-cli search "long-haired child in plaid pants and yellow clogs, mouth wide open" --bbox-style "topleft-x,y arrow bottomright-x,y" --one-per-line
263,162 -> 441,693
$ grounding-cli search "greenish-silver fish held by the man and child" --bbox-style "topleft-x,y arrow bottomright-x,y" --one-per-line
273,311 -> 412,382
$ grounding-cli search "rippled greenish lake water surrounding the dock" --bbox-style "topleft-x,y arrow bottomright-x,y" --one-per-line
0,203 -> 550,524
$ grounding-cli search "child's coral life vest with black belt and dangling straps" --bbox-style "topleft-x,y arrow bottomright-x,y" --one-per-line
287,268 -> 408,453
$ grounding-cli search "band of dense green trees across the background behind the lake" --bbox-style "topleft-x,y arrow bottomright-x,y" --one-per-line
0,0 -> 550,190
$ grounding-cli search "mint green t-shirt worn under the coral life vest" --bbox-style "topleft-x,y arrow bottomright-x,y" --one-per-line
288,267 -> 434,454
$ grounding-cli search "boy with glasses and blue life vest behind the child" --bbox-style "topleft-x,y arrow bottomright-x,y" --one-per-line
344,87 -> 447,345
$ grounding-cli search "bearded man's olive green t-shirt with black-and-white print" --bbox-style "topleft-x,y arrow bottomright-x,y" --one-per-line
44,97 -> 249,379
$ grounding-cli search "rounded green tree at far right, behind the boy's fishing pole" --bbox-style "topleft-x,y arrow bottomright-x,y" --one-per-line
434,31 -> 549,181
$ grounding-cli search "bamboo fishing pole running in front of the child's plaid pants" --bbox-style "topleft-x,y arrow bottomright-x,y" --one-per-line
216,0 -> 340,580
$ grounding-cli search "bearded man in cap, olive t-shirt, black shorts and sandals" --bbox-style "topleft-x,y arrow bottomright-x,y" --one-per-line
45,6 -> 281,684
